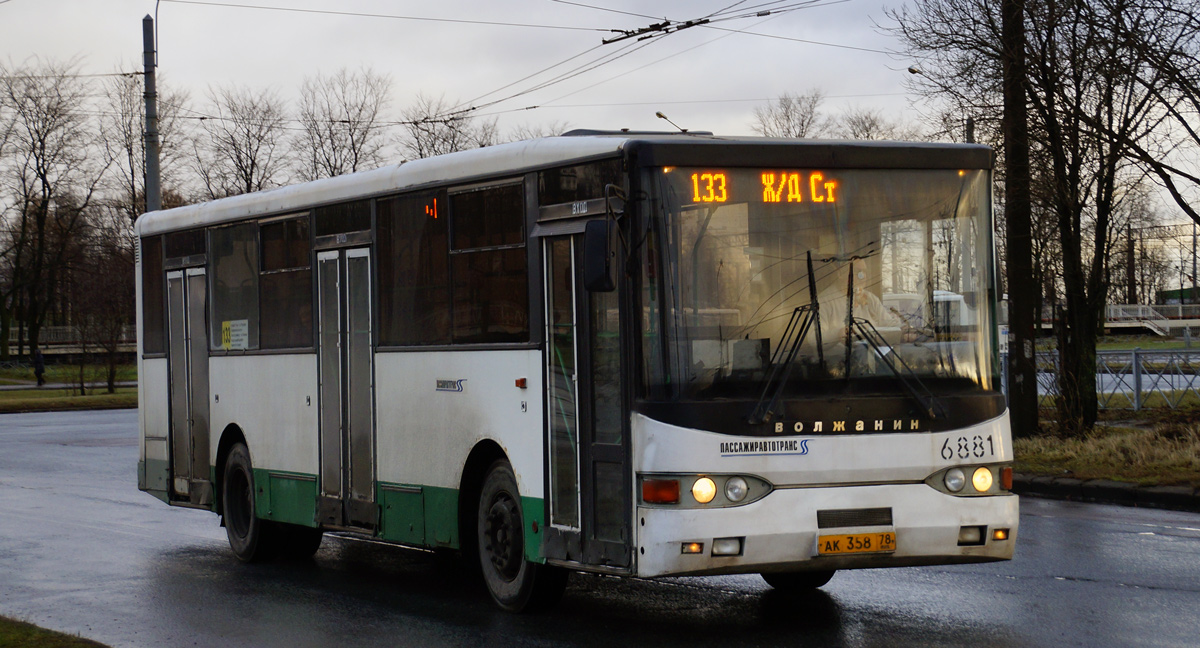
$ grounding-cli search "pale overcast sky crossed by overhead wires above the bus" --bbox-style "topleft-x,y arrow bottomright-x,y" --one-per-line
0,0 -> 917,134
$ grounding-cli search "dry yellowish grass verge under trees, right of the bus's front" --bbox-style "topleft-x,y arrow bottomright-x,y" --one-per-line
1014,419 -> 1200,487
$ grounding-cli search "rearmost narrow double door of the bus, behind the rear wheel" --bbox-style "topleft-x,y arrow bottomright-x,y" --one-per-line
167,268 -> 212,504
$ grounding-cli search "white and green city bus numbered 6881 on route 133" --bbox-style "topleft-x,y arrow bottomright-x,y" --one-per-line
136,131 -> 1018,611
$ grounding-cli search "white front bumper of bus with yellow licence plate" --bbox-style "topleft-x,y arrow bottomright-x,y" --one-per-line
635,484 -> 1018,577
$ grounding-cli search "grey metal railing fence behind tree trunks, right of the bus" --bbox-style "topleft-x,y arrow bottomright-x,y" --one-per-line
1001,349 -> 1200,412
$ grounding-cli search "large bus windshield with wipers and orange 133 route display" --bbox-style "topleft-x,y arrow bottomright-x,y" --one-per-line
636,167 -> 997,408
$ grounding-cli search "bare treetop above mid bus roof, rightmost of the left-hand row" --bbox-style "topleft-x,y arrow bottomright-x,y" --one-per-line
400,94 -> 499,158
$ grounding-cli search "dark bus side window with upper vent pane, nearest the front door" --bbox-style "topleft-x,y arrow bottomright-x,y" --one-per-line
450,184 -> 529,343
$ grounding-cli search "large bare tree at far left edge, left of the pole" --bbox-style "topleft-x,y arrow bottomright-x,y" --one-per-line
0,59 -> 106,356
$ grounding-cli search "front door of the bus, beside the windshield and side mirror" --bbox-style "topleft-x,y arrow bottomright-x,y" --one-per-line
545,235 -> 631,568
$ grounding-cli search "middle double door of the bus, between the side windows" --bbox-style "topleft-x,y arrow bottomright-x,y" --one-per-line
317,247 -> 379,528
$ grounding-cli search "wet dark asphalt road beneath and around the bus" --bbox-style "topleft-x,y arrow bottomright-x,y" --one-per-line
0,410 -> 1200,648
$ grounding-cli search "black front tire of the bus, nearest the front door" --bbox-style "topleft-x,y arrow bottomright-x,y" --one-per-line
475,460 -> 566,612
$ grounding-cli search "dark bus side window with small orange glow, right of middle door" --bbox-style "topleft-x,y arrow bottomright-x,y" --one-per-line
376,191 -> 450,347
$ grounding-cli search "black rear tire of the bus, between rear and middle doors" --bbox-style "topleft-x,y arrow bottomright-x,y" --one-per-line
221,443 -> 277,563
